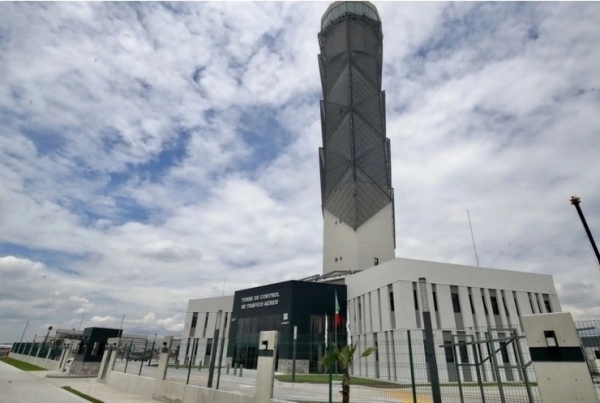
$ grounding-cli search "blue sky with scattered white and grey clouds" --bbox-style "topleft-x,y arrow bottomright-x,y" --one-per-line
0,2 -> 600,342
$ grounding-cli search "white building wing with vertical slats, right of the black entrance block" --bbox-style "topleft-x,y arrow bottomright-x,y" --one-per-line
345,258 -> 561,382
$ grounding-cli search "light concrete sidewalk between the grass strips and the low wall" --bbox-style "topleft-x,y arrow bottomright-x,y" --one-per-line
30,371 -> 156,403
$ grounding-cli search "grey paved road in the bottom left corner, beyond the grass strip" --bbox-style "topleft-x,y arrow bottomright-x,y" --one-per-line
0,362 -> 87,403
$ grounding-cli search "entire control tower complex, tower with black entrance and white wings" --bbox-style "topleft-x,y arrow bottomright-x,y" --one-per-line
180,2 -> 561,383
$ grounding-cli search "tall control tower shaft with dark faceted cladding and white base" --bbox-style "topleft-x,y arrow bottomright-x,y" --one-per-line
319,1 -> 395,274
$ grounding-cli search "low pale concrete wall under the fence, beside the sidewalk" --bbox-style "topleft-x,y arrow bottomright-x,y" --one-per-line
106,371 -> 292,403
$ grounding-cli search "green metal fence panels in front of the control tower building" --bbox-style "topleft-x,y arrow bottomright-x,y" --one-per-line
127,327 -> 541,403
